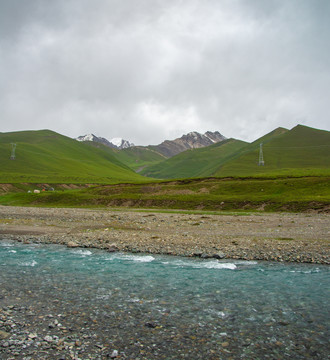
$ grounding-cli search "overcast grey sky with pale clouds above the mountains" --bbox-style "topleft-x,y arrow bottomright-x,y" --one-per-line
0,0 -> 330,145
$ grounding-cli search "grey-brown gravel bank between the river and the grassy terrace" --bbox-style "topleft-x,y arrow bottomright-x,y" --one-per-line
0,206 -> 330,264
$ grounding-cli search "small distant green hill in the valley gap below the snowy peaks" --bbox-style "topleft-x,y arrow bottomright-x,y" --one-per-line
113,146 -> 166,172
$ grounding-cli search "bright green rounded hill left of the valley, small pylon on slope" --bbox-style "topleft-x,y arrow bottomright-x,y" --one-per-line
0,130 -> 145,183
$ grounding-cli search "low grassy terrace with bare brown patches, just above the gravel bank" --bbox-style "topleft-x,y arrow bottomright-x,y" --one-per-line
0,177 -> 330,211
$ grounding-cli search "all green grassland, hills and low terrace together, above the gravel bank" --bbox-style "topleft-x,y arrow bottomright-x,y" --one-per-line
0,125 -> 330,212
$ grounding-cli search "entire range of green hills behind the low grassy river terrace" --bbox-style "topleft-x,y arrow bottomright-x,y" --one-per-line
0,125 -> 330,184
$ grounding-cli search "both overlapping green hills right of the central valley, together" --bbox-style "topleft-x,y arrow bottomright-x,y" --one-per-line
141,125 -> 330,179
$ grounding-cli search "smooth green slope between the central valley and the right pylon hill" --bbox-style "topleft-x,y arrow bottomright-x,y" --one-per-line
141,139 -> 246,179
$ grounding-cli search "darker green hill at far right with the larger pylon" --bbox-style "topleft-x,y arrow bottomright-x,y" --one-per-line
214,125 -> 330,177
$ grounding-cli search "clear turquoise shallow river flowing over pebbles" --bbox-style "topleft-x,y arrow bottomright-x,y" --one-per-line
0,240 -> 329,359
